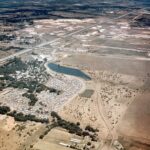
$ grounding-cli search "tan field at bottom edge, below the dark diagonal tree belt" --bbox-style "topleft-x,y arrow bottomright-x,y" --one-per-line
33,128 -> 100,150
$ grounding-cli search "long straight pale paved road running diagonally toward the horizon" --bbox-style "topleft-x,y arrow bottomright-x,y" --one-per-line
0,9 -> 143,62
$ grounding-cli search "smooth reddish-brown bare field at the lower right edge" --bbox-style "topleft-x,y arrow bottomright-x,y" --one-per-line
119,93 -> 150,144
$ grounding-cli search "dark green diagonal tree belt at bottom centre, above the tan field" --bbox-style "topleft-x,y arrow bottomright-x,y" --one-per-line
51,111 -> 98,141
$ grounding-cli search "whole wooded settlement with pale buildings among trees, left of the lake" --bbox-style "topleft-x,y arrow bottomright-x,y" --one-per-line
0,58 -> 61,106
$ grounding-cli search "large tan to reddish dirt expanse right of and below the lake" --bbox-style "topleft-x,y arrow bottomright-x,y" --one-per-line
61,55 -> 150,150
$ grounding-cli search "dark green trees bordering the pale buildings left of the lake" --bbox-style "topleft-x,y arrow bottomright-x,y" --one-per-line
0,58 -> 61,106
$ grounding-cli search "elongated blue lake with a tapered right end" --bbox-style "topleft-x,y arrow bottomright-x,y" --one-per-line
48,63 -> 91,80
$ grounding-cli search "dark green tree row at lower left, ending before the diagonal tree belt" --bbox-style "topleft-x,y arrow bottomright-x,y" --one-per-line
7,111 -> 49,123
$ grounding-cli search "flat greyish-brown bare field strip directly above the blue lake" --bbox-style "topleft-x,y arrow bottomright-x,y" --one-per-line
63,54 -> 150,76
